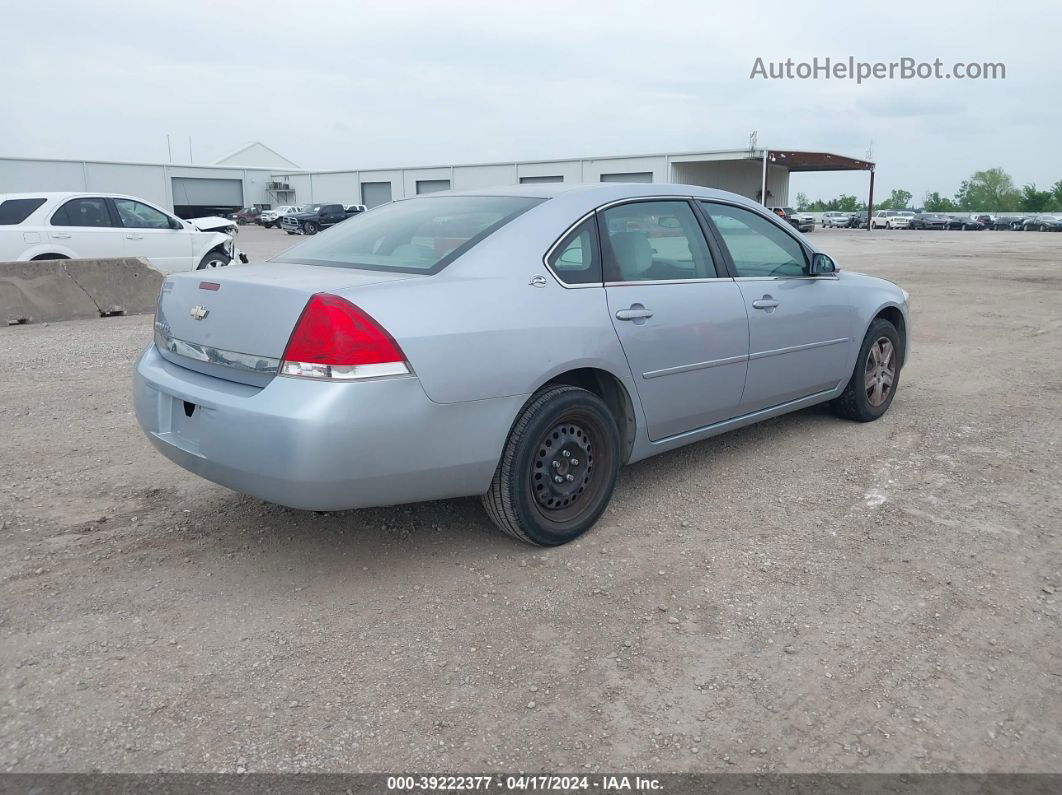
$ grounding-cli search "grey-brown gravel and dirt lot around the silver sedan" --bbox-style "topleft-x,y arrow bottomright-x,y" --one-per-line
0,229 -> 1062,772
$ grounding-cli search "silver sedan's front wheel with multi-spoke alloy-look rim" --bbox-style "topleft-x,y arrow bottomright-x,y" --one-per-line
832,317 -> 902,422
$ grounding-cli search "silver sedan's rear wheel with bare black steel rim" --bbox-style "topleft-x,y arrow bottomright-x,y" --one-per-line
482,386 -> 619,547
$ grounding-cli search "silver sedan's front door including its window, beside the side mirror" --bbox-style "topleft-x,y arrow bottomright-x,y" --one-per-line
701,201 -> 857,414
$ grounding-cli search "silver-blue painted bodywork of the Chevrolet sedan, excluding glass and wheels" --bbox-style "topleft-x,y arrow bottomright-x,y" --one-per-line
134,184 -> 910,509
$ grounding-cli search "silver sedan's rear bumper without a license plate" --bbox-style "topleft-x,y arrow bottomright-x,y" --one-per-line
134,345 -> 525,511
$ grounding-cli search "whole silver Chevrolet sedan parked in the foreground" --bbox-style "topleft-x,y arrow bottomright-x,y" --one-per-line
134,183 -> 910,545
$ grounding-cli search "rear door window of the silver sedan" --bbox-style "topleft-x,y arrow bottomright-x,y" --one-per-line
600,201 -> 716,281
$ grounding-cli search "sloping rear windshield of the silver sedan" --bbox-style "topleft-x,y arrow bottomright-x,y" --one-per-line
273,196 -> 545,274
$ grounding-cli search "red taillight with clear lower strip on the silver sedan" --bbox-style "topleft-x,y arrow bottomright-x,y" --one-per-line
280,293 -> 409,380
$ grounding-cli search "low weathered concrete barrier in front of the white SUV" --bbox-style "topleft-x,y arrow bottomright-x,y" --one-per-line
0,257 -> 162,325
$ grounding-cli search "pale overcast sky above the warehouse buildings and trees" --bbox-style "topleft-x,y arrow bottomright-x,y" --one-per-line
0,0 -> 1062,198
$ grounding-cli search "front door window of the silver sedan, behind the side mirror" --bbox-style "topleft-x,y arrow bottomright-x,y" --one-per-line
701,202 -> 807,276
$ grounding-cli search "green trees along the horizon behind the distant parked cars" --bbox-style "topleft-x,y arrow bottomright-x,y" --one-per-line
797,169 -> 1062,212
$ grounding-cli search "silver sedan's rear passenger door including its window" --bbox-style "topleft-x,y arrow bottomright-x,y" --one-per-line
598,198 -> 749,440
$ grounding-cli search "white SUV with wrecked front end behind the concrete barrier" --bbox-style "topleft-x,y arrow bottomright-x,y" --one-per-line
0,192 -> 247,274
